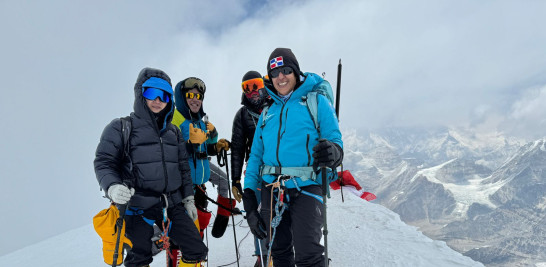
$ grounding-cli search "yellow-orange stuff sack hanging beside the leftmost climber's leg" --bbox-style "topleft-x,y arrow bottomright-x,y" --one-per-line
93,204 -> 133,265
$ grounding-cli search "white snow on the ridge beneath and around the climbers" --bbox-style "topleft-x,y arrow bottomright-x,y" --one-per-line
0,187 -> 483,267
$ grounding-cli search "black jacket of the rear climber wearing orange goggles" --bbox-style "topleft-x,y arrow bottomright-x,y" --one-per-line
227,94 -> 270,185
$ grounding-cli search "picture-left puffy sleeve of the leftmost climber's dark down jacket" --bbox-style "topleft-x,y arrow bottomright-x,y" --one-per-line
93,118 -> 123,192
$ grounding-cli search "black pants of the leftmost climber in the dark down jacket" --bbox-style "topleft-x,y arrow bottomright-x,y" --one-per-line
124,204 -> 208,267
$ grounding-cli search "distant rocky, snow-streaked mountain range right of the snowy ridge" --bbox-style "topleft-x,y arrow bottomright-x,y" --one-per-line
343,127 -> 546,266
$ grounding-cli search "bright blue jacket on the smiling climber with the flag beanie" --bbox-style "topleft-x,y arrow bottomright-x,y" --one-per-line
244,73 -> 343,191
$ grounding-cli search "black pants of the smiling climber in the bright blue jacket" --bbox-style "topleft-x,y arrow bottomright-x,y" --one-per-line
260,185 -> 324,267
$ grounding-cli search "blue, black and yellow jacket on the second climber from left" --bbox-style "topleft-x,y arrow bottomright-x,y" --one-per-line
172,82 -> 218,185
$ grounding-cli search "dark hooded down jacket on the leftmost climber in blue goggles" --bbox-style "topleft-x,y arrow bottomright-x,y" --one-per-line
94,68 -> 193,209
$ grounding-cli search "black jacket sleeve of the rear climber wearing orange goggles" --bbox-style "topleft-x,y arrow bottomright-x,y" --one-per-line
231,108 -> 247,181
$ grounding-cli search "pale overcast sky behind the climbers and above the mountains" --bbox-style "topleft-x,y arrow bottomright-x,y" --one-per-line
0,0 -> 546,255
